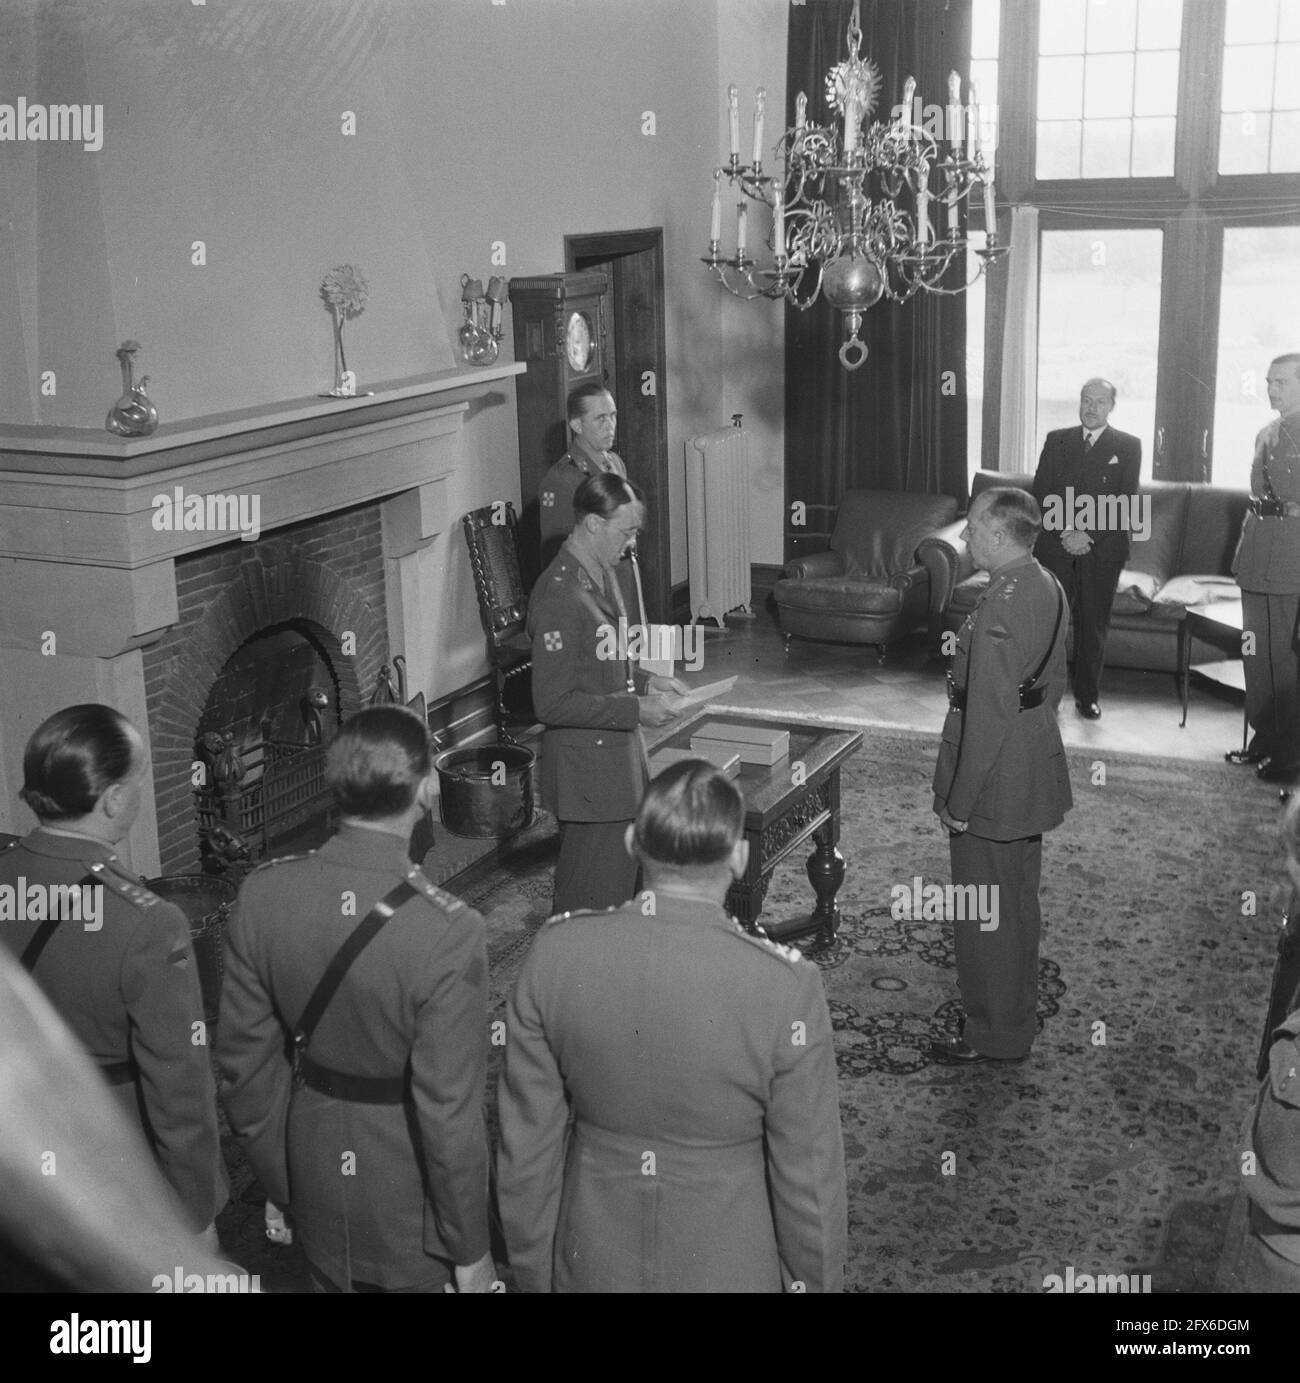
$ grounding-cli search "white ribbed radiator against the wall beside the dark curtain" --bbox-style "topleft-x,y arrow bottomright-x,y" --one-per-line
686,427 -> 751,626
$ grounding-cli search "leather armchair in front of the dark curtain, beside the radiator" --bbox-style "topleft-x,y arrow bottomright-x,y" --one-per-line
773,490 -> 957,660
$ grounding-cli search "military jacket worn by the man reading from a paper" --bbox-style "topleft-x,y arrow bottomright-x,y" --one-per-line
528,542 -> 647,822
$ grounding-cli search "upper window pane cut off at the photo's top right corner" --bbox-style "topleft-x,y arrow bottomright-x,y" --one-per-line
1218,0 -> 1300,173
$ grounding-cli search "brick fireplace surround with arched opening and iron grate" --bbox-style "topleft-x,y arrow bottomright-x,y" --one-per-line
144,503 -> 390,874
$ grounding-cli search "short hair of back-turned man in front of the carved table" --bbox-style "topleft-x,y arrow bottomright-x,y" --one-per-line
633,759 -> 745,869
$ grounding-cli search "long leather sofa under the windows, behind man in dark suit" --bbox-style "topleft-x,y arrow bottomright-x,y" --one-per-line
917,470 -> 1250,672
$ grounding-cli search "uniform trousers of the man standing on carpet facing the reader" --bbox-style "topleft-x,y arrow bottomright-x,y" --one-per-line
949,831 -> 1043,1058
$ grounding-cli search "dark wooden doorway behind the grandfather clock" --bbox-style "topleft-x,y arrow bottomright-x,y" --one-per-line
564,225 -> 672,622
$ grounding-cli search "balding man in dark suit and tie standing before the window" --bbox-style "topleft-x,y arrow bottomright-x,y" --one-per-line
1033,379 -> 1142,721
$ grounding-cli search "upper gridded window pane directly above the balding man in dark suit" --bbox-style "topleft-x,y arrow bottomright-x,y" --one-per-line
1037,0 -> 1182,178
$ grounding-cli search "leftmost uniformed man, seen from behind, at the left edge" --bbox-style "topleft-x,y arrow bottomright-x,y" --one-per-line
0,704 -> 228,1250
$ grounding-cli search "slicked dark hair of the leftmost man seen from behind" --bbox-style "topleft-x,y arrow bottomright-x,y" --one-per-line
18,701 -> 138,822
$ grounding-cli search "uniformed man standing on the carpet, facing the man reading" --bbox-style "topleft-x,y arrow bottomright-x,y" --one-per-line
932,488 -> 1073,1065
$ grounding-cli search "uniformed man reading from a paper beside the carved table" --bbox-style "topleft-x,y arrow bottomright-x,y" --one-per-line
528,474 -> 689,913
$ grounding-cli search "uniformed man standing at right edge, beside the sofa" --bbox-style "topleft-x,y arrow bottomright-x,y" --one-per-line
1225,354 -> 1300,783
